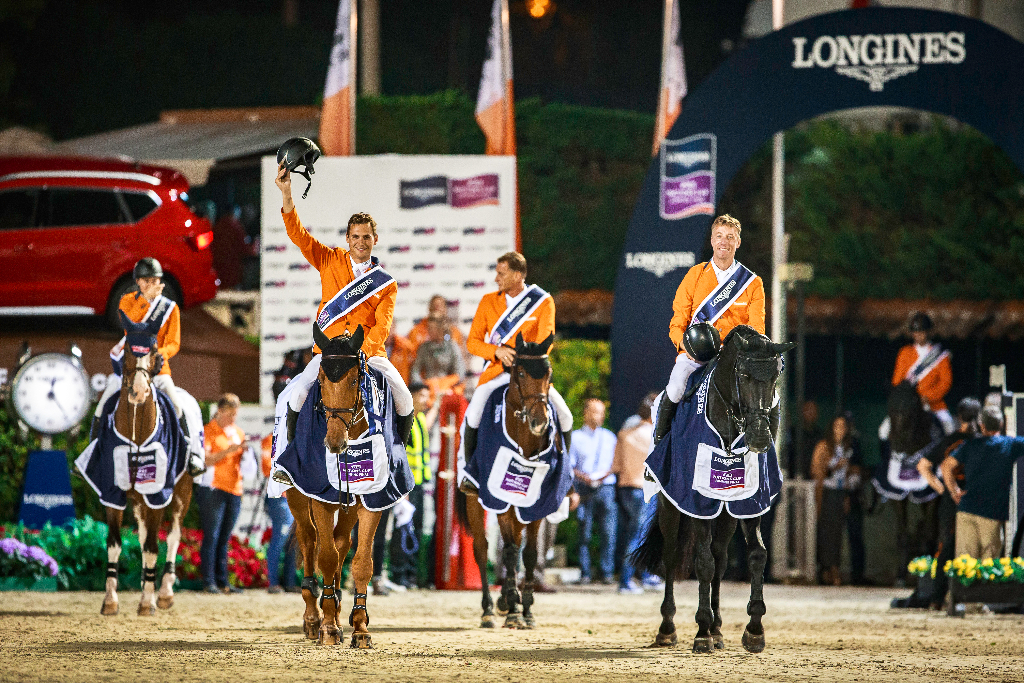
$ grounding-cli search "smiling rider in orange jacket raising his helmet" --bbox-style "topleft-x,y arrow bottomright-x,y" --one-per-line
275,165 -> 413,442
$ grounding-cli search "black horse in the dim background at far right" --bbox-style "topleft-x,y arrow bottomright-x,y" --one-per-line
872,382 -> 942,589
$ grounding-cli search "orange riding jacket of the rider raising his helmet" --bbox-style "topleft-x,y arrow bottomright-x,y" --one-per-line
282,209 -> 398,356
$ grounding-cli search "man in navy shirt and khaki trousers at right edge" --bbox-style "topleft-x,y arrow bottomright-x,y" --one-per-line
942,405 -> 1024,560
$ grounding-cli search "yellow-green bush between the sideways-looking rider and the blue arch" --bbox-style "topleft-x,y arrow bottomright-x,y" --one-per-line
551,339 -> 611,427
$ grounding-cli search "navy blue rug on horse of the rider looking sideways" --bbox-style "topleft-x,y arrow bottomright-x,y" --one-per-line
466,386 -> 572,524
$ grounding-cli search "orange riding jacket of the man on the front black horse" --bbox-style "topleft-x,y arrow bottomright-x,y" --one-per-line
669,261 -> 765,353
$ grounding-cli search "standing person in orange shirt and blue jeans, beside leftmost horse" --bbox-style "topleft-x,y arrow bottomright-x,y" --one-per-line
196,393 -> 246,593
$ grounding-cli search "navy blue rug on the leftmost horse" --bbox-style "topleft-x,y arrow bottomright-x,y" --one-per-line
75,387 -> 188,510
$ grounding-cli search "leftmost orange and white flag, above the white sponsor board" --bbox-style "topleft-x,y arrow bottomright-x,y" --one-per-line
319,0 -> 355,157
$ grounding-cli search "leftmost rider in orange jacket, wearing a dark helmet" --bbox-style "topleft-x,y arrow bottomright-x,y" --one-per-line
93,256 -> 184,426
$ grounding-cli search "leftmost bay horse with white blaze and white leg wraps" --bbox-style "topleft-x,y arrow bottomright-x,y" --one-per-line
100,311 -> 193,616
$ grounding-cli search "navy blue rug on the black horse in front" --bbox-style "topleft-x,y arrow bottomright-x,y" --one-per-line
644,371 -> 782,519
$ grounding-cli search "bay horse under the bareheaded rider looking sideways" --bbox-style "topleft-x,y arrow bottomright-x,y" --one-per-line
456,335 -> 558,629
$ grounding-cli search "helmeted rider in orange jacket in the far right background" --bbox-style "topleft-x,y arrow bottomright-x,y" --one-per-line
893,311 -> 956,434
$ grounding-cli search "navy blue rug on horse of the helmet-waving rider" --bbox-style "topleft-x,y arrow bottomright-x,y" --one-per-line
274,366 -> 414,512
